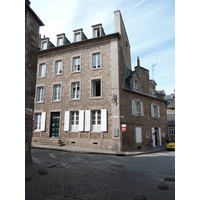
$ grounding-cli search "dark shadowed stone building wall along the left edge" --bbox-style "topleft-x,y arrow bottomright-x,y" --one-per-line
25,0 -> 44,163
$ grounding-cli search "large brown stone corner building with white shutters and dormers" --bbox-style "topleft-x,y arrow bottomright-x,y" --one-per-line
32,10 -> 167,151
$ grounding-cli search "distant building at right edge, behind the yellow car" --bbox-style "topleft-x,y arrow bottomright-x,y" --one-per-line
165,92 -> 175,140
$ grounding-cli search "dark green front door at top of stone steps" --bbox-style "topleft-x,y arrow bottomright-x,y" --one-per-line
50,112 -> 60,137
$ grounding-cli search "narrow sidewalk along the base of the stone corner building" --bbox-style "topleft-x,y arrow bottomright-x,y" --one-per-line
31,143 -> 166,156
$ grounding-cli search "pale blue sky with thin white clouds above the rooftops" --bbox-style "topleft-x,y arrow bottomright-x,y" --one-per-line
30,0 -> 175,94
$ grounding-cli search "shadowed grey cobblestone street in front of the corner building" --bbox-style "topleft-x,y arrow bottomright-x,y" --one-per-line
25,149 -> 175,200
